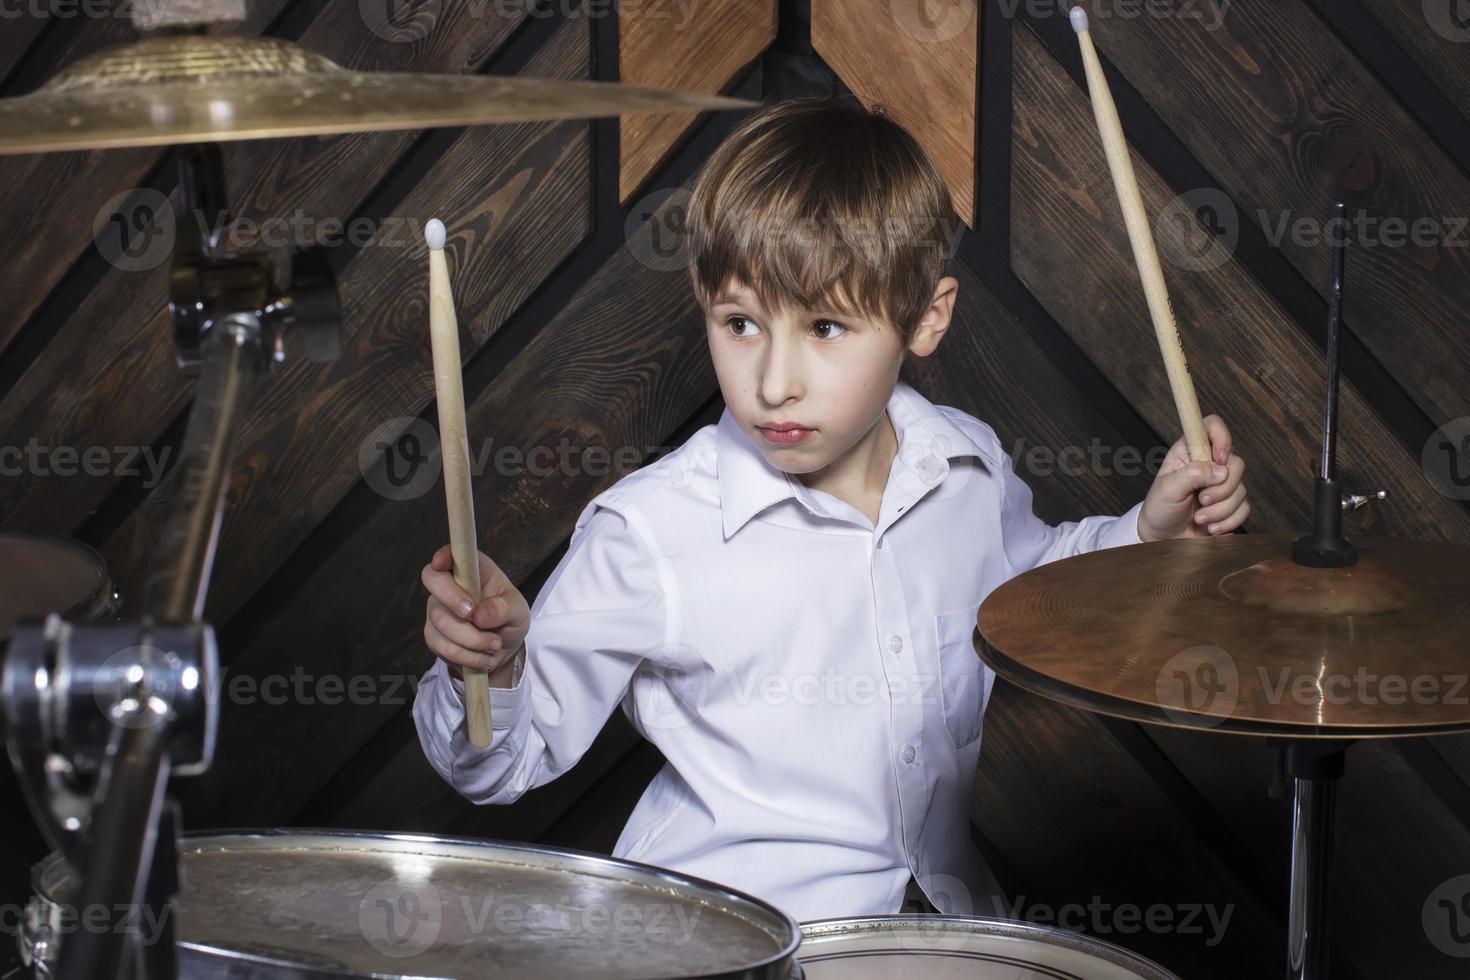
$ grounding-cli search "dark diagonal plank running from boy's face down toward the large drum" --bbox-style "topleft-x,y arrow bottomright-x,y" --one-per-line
171,189 -> 714,824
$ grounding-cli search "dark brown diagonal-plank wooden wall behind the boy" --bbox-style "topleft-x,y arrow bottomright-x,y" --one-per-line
0,0 -> 1470,980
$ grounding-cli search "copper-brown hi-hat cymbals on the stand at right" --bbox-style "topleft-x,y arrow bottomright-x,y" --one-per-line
975,533 -> 1470,738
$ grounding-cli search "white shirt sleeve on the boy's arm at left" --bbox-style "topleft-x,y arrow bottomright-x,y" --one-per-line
413,501 -> 669,804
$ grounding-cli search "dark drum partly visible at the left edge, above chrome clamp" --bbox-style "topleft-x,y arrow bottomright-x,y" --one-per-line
0,530 -> 118,646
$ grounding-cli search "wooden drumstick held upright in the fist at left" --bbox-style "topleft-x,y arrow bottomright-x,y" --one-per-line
423,217 -> 490,748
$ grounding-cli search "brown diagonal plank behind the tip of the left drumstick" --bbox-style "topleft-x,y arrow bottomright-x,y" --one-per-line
103,21 -> 591,621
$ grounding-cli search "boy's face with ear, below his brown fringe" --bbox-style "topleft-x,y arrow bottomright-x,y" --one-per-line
704,276 -> 957,475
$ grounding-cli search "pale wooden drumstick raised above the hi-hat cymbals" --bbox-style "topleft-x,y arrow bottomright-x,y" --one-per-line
1070,7 -> 1210,463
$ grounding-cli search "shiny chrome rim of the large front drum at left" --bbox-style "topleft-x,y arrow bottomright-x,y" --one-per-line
31,827 -> 803,980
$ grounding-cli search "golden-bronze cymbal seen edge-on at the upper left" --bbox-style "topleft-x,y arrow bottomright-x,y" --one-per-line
0,34 -> 756,156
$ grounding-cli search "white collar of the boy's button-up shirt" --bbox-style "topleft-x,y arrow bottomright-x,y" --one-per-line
714,379 -> 1000,539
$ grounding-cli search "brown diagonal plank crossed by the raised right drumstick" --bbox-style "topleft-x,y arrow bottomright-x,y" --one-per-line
1011,29 -> 1470,542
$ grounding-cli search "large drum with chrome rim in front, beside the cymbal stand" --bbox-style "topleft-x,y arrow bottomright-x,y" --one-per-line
22,830 -> 801,980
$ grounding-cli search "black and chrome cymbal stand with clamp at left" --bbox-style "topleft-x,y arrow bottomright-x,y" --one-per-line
0,144 -> 340,980
